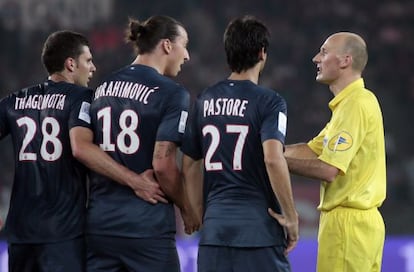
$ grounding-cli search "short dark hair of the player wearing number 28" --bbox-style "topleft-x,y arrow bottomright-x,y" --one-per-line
42,30 -> 89,74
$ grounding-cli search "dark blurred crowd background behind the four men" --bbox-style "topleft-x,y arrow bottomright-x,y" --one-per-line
0,0 -> 414,237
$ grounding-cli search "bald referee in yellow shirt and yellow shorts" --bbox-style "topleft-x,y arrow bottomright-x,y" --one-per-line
285,32 -> 386,272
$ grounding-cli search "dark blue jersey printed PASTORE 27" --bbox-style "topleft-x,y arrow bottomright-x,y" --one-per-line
182,80 -> 287,247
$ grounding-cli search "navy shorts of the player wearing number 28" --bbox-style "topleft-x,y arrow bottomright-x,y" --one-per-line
8,237 -> 86,272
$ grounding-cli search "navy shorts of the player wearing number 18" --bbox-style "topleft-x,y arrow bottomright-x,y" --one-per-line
87,235 -> 180,272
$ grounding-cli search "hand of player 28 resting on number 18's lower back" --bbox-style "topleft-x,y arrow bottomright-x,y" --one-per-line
132,169 -> 168,204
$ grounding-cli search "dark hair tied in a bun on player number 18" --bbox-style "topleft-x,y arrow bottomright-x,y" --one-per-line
126,15 -> 184,54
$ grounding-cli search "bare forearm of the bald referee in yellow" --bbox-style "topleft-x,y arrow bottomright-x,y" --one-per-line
284,143 -> 339,182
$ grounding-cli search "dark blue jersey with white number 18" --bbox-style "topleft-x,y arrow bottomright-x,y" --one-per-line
88,65 -> 189,238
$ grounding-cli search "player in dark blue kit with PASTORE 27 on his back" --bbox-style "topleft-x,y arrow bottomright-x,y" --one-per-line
182,16 -> 299,272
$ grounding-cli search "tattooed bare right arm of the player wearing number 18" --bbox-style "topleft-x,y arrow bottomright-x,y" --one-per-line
152,141 -> 199,232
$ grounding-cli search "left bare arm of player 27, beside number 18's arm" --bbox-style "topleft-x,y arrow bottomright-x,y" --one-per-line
183,154 -> 204,231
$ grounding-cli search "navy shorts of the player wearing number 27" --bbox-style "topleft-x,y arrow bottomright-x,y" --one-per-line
197,246 -> 290,272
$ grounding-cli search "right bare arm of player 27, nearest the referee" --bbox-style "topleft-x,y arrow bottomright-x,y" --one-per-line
263,140 -> 299,253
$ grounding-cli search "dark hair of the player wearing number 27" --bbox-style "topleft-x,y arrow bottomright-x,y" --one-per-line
224,15 -> 270,73
